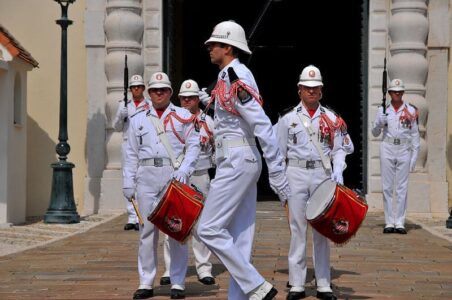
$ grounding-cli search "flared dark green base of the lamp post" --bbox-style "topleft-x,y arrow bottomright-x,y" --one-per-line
44,161 -> 80,224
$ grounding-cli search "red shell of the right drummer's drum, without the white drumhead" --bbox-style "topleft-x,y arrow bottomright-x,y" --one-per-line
308,184 -> 368,244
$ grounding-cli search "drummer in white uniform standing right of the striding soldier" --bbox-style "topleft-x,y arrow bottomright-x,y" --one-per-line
275,65 -> 346,300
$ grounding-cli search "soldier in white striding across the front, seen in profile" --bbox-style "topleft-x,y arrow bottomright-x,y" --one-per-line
198,21 -> 290,300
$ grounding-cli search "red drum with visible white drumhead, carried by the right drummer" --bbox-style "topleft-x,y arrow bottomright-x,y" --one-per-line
306,179 -> 368,244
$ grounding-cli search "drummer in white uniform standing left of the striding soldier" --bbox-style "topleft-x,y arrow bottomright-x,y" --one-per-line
123,72 -> 200,299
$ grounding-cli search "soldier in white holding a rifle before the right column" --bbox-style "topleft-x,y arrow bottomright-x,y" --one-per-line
372,79 -> 419,234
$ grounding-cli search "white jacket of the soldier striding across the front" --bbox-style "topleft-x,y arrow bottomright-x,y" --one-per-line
214,58 -> 284,173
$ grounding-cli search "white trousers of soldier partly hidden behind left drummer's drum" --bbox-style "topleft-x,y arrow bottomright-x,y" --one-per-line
163,171 -> 212,279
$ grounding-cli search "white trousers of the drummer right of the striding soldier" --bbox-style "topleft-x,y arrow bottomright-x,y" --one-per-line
286,166 -> 331,292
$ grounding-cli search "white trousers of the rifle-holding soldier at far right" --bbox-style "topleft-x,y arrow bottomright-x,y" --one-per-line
380,142 -> 411,227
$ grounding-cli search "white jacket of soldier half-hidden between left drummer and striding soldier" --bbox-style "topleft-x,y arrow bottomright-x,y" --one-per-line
195,114 -> 214,170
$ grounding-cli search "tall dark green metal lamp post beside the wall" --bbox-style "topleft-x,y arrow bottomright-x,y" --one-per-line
44,0 -> 80,224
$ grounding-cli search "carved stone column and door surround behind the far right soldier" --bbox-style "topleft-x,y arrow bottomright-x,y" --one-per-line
366,0 -> 450,217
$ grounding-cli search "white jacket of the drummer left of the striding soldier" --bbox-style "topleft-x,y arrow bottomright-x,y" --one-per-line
123,103 -> 200,188
